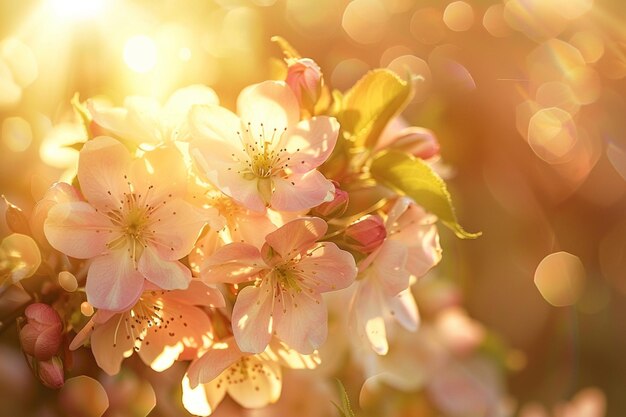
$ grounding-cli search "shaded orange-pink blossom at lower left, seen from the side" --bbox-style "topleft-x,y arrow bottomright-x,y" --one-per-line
70,280 -> 224,375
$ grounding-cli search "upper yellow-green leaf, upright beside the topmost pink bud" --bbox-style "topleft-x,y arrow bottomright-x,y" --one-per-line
339,69 -> 413,148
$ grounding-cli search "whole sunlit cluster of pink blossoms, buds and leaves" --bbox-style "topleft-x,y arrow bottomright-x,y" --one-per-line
0,39 -> 480,415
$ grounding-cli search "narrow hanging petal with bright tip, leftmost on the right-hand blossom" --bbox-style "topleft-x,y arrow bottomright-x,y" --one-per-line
352,277 -> 389,355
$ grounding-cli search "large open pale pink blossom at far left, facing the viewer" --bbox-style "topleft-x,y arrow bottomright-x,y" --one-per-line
44,136 -> 204,311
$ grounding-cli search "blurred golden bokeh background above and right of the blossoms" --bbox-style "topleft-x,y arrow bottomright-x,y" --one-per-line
0,0 -> 626,417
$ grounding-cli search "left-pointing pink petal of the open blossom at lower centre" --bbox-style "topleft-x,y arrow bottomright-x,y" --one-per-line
200,243 -> 266,284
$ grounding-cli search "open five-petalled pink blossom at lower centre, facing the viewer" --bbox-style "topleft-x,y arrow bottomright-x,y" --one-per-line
202,217 -> 356,354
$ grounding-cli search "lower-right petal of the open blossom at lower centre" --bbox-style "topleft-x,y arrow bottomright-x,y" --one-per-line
274,291 -> 328,354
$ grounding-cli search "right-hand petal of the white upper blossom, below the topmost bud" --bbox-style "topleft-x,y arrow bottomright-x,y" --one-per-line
280,116 -> 339,173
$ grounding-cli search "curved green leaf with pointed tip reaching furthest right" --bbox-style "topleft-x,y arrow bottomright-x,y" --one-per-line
370,151 -> 481,239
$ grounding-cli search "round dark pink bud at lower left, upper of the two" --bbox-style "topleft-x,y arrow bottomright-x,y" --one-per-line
20,303 -> 63,361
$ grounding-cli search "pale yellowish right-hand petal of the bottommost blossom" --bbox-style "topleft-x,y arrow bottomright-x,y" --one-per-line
227,356 -> 282,408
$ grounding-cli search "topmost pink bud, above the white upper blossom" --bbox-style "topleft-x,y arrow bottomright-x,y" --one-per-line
285,58 -> 323,109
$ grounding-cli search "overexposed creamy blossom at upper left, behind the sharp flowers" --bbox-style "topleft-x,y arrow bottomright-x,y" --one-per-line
87,85 -> 219,146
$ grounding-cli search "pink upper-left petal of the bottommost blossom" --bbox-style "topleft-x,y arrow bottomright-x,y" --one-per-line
187,337 -> 244,388
